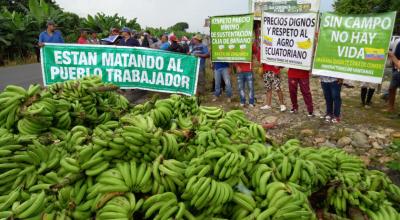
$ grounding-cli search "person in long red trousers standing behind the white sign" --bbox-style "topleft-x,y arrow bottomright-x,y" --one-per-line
288,68 -> 314,117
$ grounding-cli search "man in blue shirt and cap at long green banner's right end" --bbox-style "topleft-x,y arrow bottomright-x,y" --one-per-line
190,34 -> 210,95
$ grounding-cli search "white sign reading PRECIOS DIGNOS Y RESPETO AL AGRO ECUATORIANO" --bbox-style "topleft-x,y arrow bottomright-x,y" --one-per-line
261,12 -> 317,70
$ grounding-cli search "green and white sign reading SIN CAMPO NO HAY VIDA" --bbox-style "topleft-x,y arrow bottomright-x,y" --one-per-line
313,12 -> 396,83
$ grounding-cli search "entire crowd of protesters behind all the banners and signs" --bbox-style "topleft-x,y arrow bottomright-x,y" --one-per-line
39,21 -> 400,123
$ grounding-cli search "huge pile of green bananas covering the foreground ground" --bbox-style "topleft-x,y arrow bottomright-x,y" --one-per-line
0,78 -> 400,220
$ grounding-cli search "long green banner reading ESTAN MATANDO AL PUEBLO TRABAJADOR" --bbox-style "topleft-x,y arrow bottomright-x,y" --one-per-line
41,44 -> 200,95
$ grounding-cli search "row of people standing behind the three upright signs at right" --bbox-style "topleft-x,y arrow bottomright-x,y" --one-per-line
209,29 -> 400,123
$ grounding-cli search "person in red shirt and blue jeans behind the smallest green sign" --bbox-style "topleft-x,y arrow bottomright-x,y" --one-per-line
234,63 -> 254,108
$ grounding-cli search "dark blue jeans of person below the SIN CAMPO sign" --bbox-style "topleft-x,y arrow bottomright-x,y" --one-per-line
321,81 -> 342,118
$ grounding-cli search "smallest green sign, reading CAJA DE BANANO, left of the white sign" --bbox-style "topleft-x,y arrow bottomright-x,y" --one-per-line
210,14 -> 254,62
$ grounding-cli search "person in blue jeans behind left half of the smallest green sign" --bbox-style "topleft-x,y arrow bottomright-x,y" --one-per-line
212,62 -> 232,102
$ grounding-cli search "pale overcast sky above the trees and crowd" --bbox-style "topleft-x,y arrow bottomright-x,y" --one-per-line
56,0 -> 334,32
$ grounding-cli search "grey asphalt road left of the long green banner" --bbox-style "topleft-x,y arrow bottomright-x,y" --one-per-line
0,63 -> 43,91
